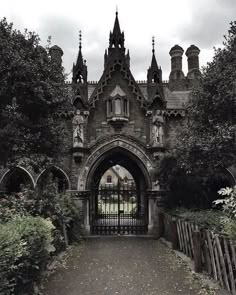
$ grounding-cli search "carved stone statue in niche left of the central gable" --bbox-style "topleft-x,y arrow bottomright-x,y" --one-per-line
72,110 -> 84,147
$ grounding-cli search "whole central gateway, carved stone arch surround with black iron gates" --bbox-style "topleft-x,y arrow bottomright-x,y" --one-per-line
78,136 -> 153,234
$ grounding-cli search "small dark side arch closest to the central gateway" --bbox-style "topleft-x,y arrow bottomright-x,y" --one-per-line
36,165 -> 71,191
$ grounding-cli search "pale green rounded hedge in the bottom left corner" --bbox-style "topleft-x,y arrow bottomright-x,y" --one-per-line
0,216 -> 55,295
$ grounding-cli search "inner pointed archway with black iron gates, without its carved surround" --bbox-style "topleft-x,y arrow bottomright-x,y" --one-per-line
86,147 -> 149,235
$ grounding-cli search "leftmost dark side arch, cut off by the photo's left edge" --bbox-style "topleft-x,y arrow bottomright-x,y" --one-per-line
0,165 -> 35,193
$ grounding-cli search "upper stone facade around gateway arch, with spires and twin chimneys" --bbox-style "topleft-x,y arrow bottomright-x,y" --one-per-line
68,14 -> 200,190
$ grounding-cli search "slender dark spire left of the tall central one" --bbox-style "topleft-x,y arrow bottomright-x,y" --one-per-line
72,30 -> 87,83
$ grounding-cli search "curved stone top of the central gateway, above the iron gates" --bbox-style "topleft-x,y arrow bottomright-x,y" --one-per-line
78,136 -> 154,190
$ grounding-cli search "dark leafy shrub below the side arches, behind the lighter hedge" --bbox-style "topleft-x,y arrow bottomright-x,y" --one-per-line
0,180 -> 81,247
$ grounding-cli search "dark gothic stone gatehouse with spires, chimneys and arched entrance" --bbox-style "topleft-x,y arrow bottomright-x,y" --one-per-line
0,13 -> 203,234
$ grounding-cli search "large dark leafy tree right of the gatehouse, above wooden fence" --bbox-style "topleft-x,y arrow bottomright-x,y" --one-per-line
158,22 -> 236,208
